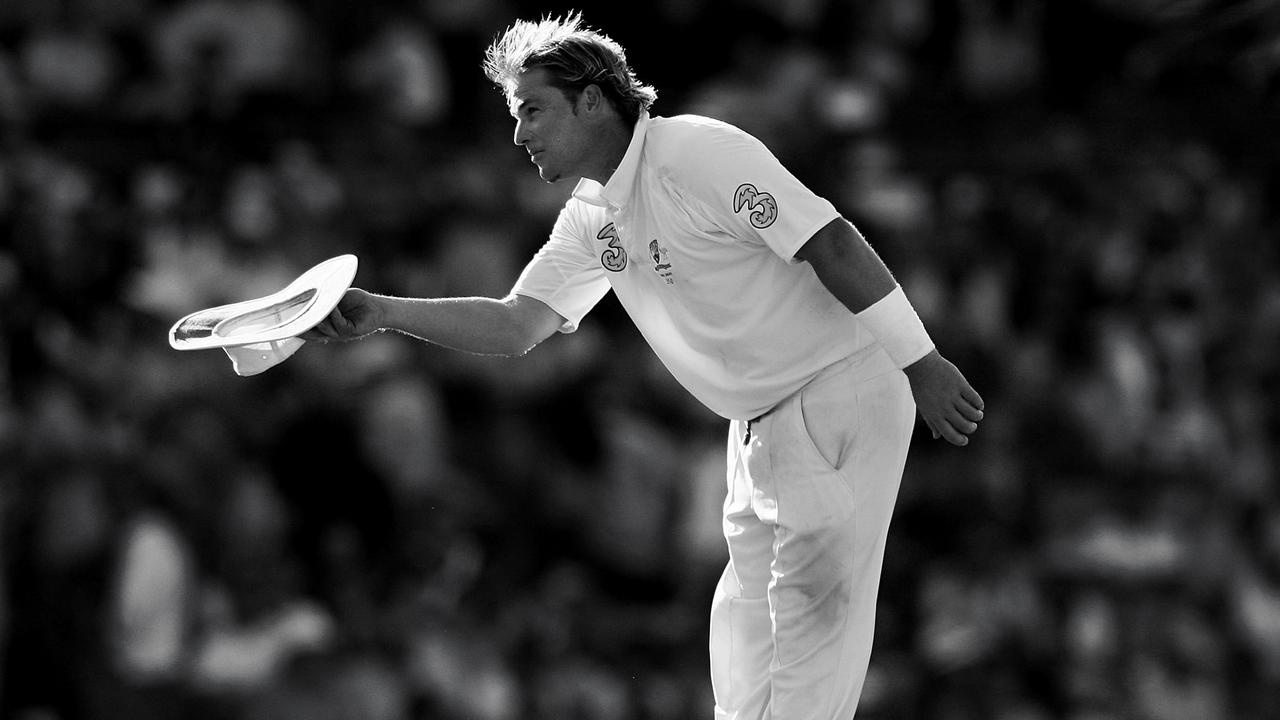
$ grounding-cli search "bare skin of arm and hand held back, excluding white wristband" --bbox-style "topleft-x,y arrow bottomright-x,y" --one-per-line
796,218 -> 983,445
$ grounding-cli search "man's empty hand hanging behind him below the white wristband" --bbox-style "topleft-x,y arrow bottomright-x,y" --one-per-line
904,350 -> 983,446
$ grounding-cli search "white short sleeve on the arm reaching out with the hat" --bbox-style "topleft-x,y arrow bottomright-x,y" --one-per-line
512,200 -> 609,333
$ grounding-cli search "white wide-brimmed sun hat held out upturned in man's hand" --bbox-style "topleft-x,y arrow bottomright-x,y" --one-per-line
169,255 -> 358,377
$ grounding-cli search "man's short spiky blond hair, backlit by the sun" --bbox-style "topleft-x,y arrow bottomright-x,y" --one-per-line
484,12 -> 658,126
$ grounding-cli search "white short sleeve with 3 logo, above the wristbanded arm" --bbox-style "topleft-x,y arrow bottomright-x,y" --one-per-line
662,122 -> 840,260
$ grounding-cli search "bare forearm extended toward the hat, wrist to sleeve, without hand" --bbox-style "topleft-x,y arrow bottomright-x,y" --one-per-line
375,295 -> 543,355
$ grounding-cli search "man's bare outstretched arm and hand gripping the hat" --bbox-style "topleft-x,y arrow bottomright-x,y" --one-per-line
302,288 -> 564,355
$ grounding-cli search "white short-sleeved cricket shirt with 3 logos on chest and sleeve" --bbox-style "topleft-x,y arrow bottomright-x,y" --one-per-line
513,109 -> 895,420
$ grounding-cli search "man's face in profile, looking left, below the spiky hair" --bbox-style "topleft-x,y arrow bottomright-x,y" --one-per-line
511,68 -> 591,182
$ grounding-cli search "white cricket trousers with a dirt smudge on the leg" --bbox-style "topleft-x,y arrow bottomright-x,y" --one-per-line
710,360 -> 915,720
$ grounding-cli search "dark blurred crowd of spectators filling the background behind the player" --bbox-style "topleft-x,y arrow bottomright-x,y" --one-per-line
0,0 -> 1280,720
